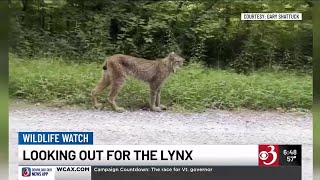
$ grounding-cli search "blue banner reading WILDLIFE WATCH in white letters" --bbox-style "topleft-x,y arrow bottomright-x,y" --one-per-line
18,132 -> 93,145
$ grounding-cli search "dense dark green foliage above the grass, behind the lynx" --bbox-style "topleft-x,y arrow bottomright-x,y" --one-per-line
10,0 -> 312,72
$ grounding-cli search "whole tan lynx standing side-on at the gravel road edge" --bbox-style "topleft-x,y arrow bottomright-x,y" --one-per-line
91,52 -> 185,112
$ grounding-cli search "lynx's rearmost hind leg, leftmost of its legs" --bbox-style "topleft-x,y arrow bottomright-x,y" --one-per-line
91,73 -> 110,108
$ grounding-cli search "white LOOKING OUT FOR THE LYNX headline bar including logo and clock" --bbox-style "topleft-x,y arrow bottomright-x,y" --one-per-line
18,145 -> 302,166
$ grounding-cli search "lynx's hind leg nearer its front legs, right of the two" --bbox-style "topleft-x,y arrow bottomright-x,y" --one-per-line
107,77 -> 125,112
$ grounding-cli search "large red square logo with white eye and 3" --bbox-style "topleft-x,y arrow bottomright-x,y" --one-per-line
259,145 -> 279,166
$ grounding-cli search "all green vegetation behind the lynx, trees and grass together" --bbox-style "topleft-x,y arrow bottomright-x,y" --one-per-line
9,0 -> 313,110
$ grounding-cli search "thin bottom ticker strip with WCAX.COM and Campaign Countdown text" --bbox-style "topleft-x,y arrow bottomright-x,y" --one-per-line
18,166 -> 302,180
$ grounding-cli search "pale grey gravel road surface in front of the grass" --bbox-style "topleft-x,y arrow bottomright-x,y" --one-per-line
9,106 -> 312,180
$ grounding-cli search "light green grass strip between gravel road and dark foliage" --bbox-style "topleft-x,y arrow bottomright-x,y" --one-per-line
9,57 -> 312,111
